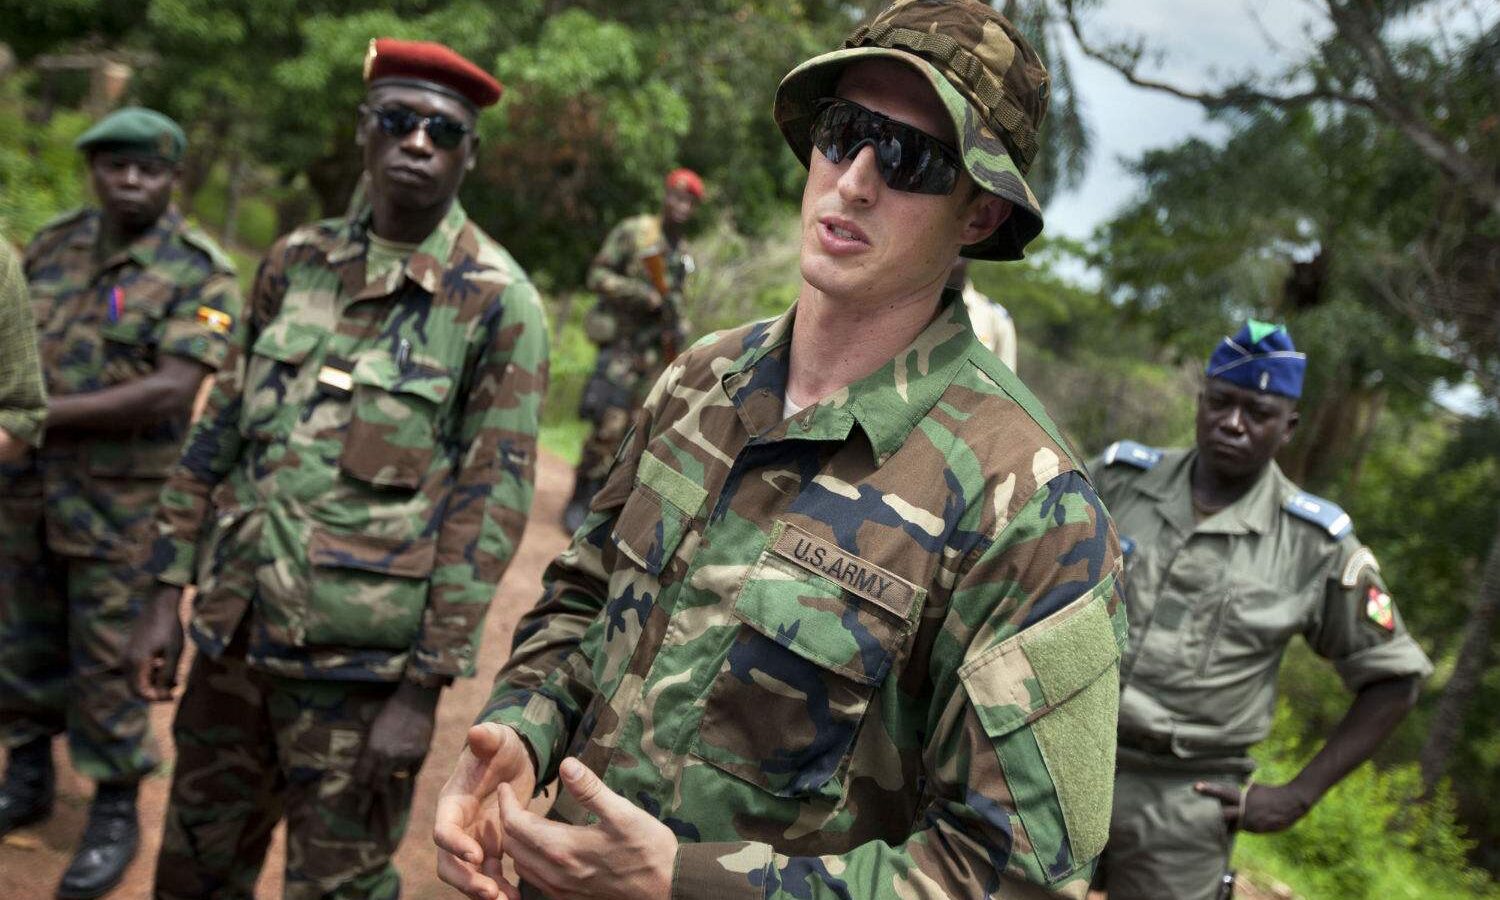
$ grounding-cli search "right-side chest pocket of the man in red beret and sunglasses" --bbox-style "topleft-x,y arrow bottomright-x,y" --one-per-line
339,350 -> 453,489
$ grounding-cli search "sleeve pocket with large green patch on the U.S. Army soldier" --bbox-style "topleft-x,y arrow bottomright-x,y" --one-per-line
959,576 -> 1119,884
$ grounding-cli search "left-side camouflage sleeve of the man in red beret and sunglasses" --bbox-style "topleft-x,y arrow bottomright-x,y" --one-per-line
147,253 -> 285,587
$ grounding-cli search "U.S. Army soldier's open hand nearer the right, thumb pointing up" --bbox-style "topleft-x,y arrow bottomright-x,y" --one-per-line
500,758 -> 677,900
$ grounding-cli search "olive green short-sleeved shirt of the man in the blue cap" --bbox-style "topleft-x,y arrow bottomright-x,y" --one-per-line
1092,443 -> 1433,770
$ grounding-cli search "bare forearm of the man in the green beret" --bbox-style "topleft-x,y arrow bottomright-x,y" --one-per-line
47,356 -> 209,431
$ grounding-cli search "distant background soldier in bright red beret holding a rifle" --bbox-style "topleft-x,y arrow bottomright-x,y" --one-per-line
563,168 -> 704,531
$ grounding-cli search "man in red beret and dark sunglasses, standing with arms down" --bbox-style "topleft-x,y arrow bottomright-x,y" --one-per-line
129,41 -> 548,899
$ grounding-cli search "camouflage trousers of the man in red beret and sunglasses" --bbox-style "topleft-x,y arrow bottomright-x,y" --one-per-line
156,630 -> 416,900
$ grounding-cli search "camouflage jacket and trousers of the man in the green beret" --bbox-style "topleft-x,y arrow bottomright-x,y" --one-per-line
0,210 -> 240,783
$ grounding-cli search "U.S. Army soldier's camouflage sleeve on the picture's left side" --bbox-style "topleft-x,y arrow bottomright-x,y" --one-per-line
477,411 -> 651,791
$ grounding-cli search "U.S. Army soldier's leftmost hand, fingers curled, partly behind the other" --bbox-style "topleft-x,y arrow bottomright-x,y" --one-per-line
432,723 -> 537,900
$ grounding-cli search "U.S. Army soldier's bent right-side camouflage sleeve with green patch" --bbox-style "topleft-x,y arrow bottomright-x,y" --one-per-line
672,473 -> 1125,900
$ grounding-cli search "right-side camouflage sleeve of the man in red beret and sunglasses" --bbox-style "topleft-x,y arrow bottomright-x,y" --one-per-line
408,281 -> 548,677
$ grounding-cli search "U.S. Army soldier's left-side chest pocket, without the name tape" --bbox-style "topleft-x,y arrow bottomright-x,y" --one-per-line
609,450 -> 708,576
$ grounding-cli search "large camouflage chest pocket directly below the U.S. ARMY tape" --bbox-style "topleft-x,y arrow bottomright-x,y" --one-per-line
692,522 -> 926,800
